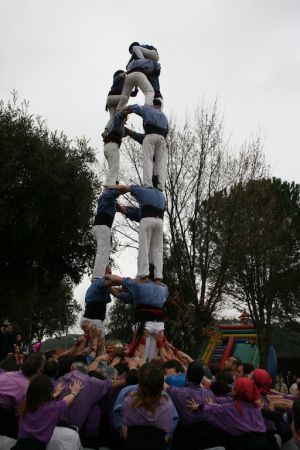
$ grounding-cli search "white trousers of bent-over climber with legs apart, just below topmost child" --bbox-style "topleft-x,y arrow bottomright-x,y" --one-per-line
117,72 -> 154,111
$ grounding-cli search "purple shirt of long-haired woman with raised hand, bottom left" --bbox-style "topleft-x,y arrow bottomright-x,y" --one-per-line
18,400 -> 68,444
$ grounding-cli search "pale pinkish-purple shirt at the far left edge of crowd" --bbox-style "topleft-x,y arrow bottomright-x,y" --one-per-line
0,372 -> 29,411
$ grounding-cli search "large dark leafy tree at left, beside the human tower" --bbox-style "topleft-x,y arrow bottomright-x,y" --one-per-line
0,96 -> 99,338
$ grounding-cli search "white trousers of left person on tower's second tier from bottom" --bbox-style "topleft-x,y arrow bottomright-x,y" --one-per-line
92,225 -> 111,281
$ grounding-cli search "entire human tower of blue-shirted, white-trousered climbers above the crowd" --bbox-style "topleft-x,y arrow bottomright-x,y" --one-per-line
81,42 -> 168,361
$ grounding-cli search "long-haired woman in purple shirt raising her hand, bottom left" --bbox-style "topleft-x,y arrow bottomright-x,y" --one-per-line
13,375 -> 84,450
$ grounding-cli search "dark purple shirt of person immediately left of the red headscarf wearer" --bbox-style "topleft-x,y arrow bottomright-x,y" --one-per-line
167,382 -> 214,425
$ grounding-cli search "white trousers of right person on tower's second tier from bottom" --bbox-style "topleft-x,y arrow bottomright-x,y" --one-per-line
137,217 -> 163,279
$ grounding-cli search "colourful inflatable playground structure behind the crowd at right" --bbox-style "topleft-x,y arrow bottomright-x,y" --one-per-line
201,324 -> 259,368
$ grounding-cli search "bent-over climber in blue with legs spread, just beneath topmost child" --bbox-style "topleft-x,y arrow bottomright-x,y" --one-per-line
117,59 -> 160,111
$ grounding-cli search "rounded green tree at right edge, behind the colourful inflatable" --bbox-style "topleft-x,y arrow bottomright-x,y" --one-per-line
213,178 -> 300,367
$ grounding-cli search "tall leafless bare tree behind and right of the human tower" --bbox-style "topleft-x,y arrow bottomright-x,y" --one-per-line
108,103 -> 266,353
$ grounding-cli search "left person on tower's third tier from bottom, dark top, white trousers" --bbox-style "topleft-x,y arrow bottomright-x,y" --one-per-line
102,112 -> 127,185
